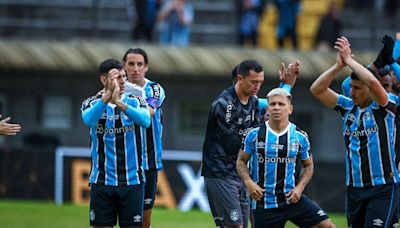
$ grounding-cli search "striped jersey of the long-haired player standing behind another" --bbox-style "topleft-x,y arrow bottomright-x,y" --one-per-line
142,79 -> 165,170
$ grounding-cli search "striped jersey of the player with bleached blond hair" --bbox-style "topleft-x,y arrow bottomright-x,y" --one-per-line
244,122 -> 311,209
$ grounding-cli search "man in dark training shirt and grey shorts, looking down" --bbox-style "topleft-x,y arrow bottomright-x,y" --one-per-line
201,60 -> 298,227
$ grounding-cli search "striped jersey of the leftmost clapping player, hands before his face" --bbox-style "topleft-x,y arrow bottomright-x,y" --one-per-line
82,94 -> 150,186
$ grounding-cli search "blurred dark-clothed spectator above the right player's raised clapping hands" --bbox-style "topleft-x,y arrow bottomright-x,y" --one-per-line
315,1 -> 342,50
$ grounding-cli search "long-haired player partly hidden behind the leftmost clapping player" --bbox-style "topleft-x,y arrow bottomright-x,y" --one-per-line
123,48 -> 165,228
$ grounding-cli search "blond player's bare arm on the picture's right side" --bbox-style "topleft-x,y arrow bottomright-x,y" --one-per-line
286,155 -> 314,203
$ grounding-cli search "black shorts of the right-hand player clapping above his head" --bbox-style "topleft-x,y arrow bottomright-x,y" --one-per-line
346,184 -> 399,228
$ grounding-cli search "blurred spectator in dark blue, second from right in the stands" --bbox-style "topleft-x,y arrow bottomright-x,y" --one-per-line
274,0 -> 300,49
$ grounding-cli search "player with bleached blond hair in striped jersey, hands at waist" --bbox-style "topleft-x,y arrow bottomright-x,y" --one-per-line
236,88 -> 334,227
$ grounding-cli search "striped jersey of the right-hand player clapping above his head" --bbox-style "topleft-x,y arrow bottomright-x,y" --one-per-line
334,95 -> 399,187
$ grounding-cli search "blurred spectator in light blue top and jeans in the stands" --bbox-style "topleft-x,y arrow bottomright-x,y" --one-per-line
158,0 -> 194,47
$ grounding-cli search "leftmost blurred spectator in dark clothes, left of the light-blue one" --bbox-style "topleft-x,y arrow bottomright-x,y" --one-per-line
126,0 -> 162,42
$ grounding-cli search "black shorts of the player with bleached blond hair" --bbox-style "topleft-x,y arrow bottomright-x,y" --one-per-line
253,195 -> 329,228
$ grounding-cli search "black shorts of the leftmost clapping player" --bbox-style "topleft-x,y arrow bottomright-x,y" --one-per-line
89,184 -> 144,227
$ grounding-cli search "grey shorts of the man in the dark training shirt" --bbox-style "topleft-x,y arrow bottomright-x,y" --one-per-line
204,177 -> 250,228
